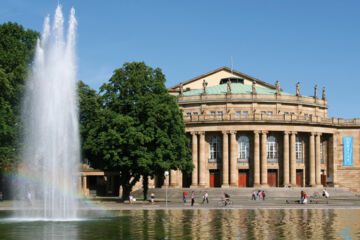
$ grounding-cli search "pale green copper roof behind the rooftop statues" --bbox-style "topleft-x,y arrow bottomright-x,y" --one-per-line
184,83 -> 294,96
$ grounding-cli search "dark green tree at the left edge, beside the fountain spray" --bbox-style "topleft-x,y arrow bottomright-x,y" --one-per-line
0,22 -> 39,172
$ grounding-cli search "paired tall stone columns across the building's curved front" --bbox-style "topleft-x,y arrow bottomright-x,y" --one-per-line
191,131 -> 321,188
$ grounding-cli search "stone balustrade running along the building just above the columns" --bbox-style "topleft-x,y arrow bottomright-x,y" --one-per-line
184,113 -> 360,126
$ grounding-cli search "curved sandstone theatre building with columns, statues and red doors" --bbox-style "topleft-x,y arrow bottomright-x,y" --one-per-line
169,67 -> 360,190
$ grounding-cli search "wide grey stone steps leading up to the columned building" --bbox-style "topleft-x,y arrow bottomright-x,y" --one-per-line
131,187 -> 359,202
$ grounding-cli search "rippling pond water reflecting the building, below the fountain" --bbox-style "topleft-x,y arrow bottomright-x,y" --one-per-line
0,209 -> 360,240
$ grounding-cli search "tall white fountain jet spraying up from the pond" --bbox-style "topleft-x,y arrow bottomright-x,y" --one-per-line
17,5 -> 80,220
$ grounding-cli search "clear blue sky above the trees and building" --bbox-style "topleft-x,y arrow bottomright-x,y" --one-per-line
0,0 -> 360,118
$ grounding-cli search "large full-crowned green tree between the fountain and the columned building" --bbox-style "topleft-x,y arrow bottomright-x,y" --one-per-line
84,62 -> 193,199
